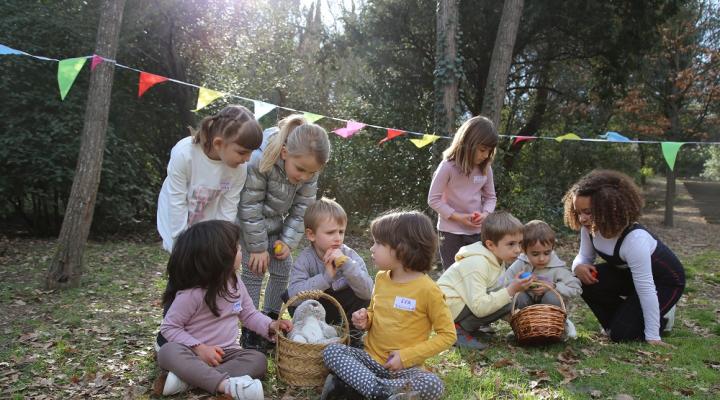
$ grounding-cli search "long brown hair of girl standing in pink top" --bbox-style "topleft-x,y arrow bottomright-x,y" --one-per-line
443,115 -> 499,176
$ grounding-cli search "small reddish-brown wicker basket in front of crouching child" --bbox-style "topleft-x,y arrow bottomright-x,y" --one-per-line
510,281 -> 567,345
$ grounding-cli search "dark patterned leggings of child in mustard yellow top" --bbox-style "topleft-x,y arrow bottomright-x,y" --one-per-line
323,343 -> 445,400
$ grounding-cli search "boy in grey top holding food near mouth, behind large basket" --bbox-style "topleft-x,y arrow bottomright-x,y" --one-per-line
283,197 -> 373,347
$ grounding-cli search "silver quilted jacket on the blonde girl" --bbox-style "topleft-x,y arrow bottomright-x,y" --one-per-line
237,127 -> 319,254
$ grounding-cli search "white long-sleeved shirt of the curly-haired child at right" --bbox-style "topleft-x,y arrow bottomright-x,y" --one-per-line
572,227 -> 660,340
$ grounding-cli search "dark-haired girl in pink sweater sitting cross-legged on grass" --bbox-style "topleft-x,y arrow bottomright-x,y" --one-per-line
154,220 -> 292,400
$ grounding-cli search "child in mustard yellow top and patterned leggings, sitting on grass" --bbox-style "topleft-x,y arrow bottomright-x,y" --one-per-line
320,211 -> 455,400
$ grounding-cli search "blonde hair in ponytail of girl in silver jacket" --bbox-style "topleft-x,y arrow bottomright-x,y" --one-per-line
260,114 -> 330,173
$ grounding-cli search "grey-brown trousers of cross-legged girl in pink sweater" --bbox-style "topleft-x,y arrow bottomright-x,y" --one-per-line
157,342 -> 267,393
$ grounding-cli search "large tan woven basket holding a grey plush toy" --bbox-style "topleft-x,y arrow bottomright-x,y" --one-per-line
275,290 -> 350,387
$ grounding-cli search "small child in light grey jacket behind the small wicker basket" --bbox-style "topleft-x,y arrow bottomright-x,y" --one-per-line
501,220 -> 582,338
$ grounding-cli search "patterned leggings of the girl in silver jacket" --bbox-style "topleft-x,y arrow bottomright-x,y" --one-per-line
240,237 -> 293,314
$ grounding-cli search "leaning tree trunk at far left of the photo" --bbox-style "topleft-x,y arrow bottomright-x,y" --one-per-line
45,0 -> 125,289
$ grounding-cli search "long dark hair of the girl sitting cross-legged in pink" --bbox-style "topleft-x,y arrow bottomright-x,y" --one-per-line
162,220 -> 240,317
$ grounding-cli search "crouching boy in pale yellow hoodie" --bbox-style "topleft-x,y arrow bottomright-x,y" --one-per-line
437,211 -> 532,349
